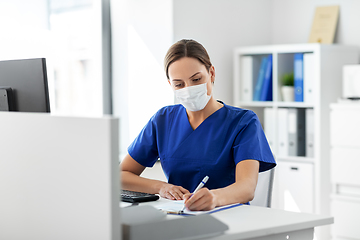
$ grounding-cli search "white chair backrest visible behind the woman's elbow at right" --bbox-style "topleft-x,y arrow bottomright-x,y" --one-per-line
250,168 -> 275,207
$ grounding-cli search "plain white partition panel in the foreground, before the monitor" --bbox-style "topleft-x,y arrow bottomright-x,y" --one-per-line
0,112 -> 120,240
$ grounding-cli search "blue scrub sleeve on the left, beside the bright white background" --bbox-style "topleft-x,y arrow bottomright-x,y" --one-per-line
128,110 -> 159,167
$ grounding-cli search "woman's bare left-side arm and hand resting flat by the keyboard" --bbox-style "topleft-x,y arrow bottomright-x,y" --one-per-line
119,154 -> 189,200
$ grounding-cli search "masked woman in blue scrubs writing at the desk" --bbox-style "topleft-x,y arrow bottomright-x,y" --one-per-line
120,40 -> 276,210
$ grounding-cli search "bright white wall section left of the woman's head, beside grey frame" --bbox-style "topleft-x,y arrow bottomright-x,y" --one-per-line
111,0 -> 173,158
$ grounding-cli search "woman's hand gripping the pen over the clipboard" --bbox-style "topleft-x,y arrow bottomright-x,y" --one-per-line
184,188 -> 216,211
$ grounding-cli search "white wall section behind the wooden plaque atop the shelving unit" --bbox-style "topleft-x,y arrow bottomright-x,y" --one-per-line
271,0 -> 360,47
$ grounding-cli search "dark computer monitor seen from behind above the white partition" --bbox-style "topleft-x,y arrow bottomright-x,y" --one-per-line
0,58 -> 50,112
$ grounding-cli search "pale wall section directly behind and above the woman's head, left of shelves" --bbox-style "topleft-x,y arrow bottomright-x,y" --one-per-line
173,0 -> 272,104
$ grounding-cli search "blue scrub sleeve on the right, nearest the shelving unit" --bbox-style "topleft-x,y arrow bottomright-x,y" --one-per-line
233,111 -> 276,172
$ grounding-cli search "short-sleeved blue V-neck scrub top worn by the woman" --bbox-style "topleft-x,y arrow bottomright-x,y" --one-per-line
128,102 -> 276,192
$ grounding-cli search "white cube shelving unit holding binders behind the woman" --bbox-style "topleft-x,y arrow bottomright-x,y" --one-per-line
234,43 -> 358,240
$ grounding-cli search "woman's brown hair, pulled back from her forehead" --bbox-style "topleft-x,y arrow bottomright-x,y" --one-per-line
164,39 -> 212,79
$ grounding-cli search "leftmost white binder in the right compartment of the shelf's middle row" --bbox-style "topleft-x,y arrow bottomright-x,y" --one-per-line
277,108 -> 289,156
